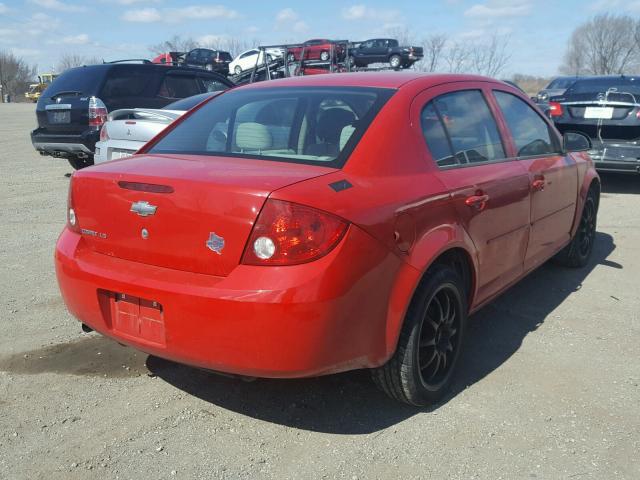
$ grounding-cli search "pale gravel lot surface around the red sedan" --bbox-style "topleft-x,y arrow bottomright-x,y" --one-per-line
0,104 -> 640,480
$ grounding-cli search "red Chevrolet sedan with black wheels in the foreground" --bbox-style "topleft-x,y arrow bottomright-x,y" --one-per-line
55,72 -> 600,405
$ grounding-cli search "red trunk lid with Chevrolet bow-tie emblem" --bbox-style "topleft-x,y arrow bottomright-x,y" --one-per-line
72,155 -> 335,276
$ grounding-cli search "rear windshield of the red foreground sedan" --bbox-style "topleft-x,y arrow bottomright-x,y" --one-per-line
149,87 -> 394,167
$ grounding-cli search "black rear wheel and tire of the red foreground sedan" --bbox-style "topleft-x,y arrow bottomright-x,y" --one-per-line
372,265 -> 467,406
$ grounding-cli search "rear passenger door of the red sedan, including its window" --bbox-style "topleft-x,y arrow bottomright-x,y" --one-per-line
418,82 -> 530,302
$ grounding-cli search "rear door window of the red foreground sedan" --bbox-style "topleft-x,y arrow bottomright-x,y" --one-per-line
421,90 -> 505,167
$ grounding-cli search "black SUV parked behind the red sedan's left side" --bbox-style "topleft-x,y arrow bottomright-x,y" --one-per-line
31,63 -> 233,169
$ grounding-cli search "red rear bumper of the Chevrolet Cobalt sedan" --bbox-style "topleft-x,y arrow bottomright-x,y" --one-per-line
55,226 -> 401,378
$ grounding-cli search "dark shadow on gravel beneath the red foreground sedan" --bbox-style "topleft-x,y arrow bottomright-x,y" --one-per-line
146,233 -> 623,434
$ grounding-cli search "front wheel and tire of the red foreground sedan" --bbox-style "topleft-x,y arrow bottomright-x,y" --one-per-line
554,189 -> 598,268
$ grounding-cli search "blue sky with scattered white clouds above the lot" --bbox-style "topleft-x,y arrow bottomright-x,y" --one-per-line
0,0 -> 640,76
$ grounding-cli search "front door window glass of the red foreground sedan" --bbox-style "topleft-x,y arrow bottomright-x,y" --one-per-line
493,90 -> 558,157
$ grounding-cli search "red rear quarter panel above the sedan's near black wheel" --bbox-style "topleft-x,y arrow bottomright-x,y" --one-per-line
271,83 -> 476,360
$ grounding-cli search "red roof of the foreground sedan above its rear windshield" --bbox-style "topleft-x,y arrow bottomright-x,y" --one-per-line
240,71 -> 502,89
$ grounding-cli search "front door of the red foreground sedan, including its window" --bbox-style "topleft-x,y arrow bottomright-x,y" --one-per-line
493,89 -> 578,270
